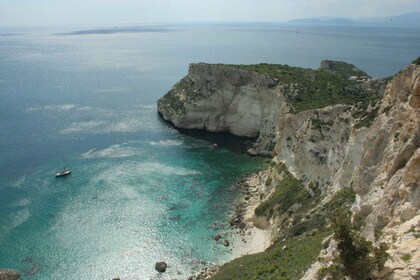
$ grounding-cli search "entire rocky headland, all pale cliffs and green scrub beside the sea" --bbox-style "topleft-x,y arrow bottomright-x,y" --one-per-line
158,60 -> 420,279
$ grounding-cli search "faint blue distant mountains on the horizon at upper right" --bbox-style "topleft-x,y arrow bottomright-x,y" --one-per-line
287,12 -> 420,27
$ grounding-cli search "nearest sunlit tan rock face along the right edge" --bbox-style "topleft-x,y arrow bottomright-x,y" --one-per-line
353,65 -> 420,279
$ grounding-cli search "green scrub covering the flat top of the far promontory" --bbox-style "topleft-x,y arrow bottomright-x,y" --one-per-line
231,62 -> 378,112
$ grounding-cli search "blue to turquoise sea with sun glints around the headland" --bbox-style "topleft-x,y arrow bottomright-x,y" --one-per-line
0,23 -> 420,280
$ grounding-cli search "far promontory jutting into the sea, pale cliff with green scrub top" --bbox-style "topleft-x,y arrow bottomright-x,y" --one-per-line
158,62 -> 385,157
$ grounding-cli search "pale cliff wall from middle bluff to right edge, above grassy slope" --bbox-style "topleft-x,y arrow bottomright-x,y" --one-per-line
275,65 -> 420,279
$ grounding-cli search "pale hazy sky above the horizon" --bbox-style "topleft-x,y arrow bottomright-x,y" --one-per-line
0,0 -> 420,25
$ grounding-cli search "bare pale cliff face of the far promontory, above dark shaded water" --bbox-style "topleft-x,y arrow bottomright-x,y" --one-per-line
158,63 -> 288,158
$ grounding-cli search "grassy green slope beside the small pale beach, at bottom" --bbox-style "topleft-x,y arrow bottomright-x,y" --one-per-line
211,170 -> 355,280
